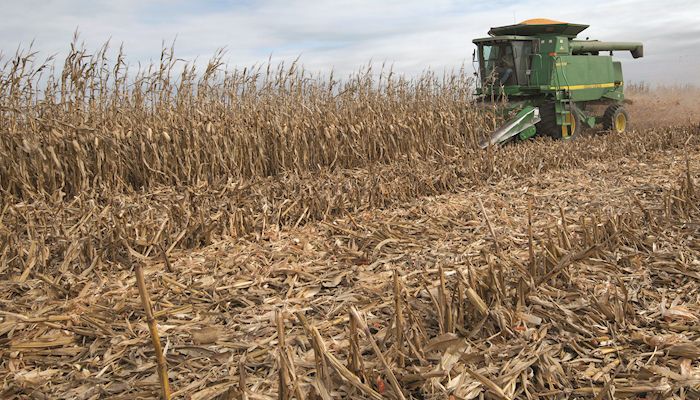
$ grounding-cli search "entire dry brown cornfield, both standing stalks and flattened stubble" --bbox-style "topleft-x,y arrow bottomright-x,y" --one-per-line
0,41 -> 700,399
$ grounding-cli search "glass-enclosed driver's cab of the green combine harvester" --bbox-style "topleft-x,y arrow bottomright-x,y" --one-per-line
479,40 -> 532,86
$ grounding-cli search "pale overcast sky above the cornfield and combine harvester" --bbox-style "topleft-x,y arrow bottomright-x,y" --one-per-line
0,0 -> 700,85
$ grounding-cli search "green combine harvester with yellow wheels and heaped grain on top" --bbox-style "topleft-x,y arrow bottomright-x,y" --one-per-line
474,19 -> 644,148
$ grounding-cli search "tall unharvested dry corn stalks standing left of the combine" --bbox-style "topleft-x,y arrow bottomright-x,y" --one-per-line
0,45 -> 498,198
